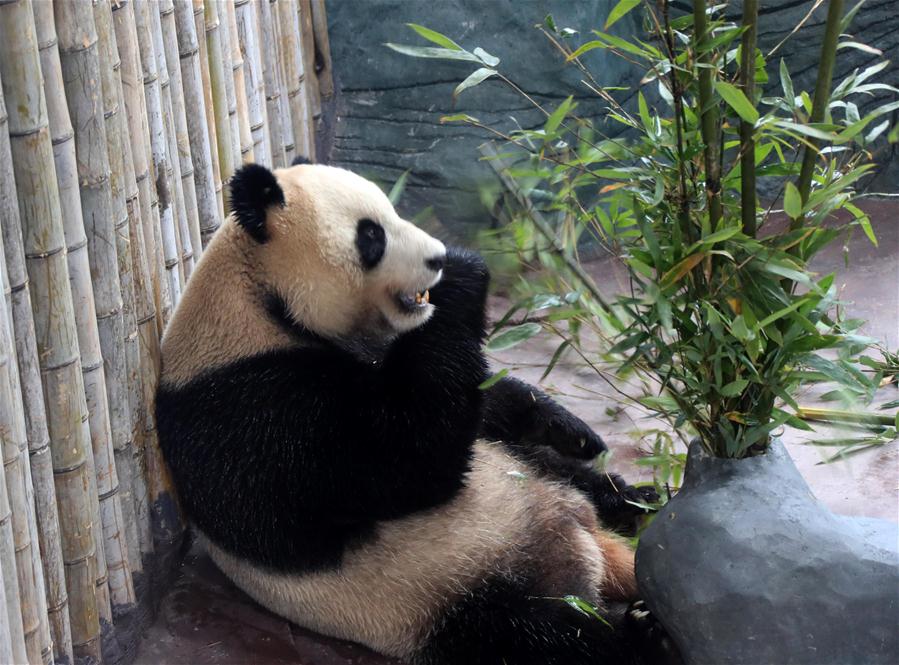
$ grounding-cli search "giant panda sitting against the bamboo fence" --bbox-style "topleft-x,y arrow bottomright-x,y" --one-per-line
156,164 -> 676,665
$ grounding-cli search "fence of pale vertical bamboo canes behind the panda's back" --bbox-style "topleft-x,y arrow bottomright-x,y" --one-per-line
0,0 -> 334,663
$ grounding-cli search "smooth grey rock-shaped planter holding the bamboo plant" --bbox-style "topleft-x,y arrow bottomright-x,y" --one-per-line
637,442 -> 899,665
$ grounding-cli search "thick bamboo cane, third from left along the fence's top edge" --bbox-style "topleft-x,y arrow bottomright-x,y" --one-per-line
54,1 -> 135,621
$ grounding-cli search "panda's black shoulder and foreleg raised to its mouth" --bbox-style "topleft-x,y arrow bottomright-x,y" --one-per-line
156,250 -> 488,571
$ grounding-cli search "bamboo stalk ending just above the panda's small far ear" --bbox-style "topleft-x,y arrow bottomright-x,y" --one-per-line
276,0 -> 315,160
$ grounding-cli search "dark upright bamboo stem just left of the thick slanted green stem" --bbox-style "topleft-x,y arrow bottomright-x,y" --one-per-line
740,0 -> 759,237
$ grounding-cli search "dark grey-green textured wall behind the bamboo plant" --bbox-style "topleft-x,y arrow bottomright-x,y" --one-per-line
325,0 -> 899,236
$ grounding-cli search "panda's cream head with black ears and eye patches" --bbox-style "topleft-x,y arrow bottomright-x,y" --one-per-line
230,160 -> 446,339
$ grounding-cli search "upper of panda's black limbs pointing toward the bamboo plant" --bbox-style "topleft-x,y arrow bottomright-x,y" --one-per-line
481,377 -> 606,459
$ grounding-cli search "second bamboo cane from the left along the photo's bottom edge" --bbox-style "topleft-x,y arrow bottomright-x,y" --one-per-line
0,209 -> 36,663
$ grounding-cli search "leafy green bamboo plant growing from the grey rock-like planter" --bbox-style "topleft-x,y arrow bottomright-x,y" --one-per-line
388,0 -> 899,458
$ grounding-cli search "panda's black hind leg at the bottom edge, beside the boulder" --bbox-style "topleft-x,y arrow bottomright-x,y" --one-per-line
414,576 -> 667,665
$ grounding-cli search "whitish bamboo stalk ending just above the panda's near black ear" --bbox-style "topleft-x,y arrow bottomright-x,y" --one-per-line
234,0 -> 272,168
